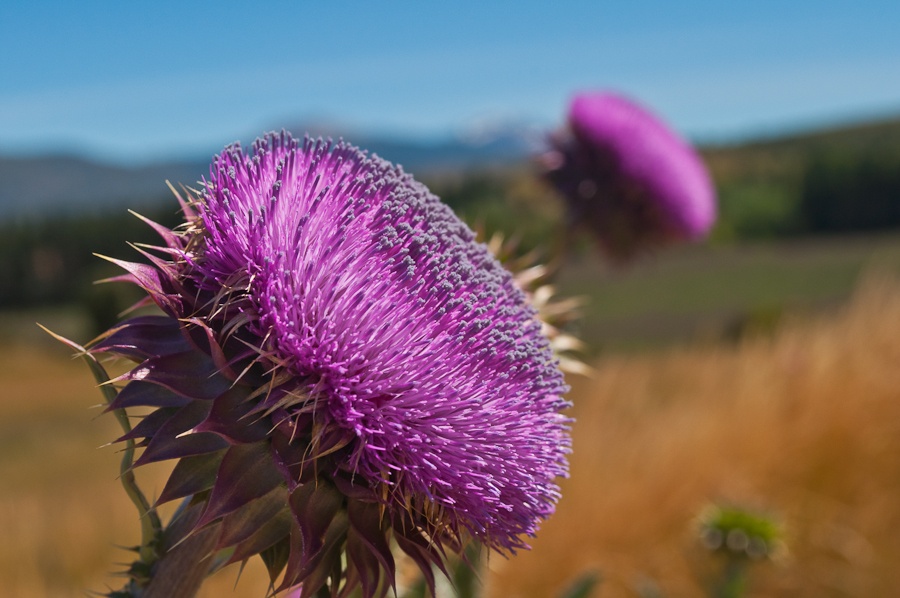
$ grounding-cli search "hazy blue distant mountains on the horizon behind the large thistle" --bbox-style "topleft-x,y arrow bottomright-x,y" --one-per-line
0,127 -> 531,220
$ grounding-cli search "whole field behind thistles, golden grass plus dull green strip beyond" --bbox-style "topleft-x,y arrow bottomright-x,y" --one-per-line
0,235 -> 900,598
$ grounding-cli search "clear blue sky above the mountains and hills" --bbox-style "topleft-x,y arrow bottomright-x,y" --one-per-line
0,0 -> 900,162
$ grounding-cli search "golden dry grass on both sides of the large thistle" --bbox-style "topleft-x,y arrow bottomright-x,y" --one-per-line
0,278 -> 900,598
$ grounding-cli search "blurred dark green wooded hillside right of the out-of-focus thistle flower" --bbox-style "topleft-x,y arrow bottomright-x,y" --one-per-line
703,120 -> 900,241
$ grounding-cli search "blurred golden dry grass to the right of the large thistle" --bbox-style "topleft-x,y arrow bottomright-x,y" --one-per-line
490,280 -> 900,598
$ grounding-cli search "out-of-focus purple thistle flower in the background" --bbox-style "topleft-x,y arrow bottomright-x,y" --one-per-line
539,93 -> 716,261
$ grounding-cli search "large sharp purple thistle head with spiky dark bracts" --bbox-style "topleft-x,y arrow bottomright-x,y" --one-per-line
88,133 -> 570,597
